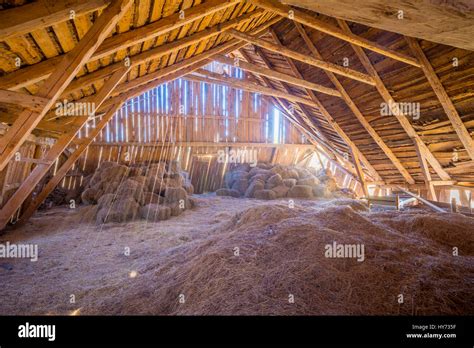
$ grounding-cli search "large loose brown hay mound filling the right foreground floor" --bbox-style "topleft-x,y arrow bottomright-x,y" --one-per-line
131,203 -> 474,315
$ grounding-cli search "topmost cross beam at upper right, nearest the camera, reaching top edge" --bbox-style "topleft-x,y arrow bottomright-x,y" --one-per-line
248,0 -> 420,67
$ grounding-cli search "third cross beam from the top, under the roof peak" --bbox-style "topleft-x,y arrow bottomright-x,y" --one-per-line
214,55 -> 341,97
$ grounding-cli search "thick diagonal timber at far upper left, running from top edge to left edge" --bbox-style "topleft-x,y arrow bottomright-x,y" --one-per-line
0,0 -> 133,170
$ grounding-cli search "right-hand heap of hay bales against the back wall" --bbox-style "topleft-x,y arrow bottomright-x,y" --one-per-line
216,163 -> 350,199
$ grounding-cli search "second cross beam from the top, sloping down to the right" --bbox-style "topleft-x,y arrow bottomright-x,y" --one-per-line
227,29 -> 375,86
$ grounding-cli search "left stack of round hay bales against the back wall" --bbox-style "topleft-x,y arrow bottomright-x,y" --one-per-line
81,161 -> 194,224
